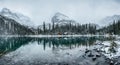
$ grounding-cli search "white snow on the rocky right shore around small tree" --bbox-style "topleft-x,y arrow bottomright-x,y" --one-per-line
94,40 -> 120,59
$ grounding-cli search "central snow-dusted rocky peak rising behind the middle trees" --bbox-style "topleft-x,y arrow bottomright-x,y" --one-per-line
52,12 -> 75,24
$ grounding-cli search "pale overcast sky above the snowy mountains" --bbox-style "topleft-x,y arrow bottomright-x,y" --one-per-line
0,0 -> 120,25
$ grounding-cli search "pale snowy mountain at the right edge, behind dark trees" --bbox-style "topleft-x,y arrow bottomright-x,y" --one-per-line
100,15 -> 120,26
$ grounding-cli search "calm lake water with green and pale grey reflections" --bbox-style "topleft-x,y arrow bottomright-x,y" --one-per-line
0,36 -> 114,65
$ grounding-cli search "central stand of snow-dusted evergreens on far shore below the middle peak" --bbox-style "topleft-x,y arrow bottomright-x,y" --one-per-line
38,22 -> 97,34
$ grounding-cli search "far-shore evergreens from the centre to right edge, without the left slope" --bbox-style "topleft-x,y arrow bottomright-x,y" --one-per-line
37,21 -> 120,35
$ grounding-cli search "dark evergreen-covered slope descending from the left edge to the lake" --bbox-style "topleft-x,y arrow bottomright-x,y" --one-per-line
0,15 -> 34,35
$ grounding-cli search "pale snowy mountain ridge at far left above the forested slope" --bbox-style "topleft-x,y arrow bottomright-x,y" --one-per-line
0,8 -> 34,27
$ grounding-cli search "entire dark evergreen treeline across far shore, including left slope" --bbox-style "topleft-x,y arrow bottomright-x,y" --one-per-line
0,15 -> 120,35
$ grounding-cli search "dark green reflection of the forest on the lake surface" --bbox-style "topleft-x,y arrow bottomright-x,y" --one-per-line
0,36 -> 111,55
